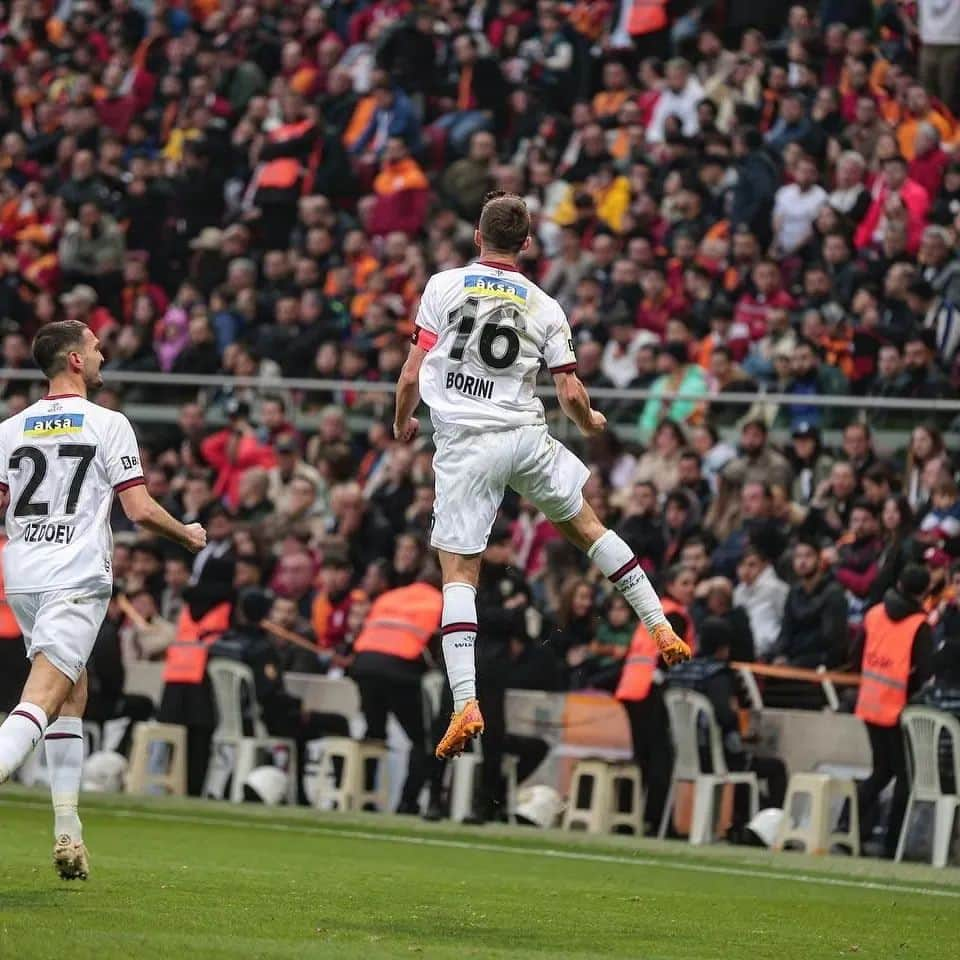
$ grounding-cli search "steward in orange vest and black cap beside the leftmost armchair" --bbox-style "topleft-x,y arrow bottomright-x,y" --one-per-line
158,557 -> 234,796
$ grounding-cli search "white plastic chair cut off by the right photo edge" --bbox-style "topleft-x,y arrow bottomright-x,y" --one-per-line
896,707 -> 960,867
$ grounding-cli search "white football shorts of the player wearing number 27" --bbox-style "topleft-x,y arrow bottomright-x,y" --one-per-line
7,587 -> 110,683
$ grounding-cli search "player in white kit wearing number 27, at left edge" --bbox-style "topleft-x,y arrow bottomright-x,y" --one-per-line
0,320 -> 207,880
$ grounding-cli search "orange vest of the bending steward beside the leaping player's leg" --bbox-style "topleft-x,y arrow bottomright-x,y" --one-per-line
353,583 -> 443,660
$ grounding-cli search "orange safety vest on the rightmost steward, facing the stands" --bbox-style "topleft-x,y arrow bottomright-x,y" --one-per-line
854,603 -> 926,727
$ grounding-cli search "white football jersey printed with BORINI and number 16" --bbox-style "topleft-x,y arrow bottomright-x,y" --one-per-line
413,261 -> 577,430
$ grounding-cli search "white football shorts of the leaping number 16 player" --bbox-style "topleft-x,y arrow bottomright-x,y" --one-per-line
430,424 -> 590,556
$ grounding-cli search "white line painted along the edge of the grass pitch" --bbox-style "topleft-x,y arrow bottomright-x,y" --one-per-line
0,800 -> 960,899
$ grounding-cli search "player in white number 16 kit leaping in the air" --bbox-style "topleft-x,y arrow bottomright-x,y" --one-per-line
393,194 -> 690,757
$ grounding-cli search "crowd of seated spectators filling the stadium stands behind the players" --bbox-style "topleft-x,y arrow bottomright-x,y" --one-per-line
0,0 -> 960,828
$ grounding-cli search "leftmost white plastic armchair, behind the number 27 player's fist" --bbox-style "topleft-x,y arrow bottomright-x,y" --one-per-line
203,657 -> 298,804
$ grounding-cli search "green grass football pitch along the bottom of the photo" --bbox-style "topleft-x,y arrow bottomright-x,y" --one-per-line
0,787 -> 960,960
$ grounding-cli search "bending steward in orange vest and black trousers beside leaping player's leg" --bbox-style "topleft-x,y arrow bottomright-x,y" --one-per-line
350,580 -> 443,813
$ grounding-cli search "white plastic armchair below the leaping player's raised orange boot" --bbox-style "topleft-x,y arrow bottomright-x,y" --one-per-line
658,690 -> 760,845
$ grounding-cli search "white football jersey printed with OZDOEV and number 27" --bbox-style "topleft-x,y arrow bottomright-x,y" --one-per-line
0,395 -> 144,593
